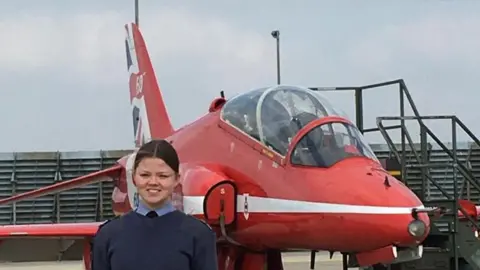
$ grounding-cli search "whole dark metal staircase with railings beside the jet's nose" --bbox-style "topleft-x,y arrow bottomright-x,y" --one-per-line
310,80 -> 480,270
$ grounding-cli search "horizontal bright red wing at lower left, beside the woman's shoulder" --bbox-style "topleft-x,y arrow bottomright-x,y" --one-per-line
0,222 -> 102,238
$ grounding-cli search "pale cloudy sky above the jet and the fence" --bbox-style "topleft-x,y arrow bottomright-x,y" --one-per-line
0,0 -> 480,152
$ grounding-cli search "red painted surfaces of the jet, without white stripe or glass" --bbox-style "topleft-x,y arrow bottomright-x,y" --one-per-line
0,21 -> 476,270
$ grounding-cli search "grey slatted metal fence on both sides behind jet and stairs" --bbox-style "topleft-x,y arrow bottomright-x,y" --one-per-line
0,143 -> 480,224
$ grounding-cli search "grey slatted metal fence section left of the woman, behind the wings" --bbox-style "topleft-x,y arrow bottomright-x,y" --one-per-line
0,150 -> 131,224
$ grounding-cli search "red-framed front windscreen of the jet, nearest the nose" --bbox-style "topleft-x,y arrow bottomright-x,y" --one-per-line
290,122 -> 378,168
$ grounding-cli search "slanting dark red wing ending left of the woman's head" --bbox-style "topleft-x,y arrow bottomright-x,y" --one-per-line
0,164 -> 123,205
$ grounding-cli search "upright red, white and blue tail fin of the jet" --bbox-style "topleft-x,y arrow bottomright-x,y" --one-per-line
125,23 -> 174,147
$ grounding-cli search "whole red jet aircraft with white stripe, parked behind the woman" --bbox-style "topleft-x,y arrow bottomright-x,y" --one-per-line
0,23 -> 430,270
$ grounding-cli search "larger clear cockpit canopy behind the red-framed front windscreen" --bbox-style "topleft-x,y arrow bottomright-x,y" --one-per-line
221,86 -> 356,156
